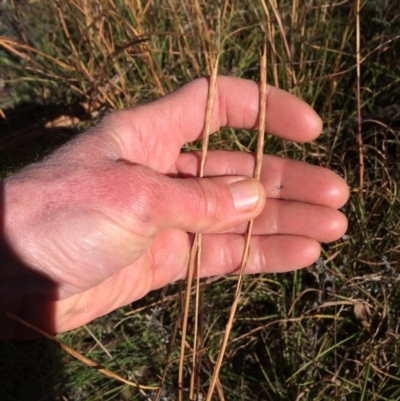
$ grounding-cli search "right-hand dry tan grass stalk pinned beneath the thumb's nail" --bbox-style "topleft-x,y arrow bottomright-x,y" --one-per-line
206,42 -> 267,401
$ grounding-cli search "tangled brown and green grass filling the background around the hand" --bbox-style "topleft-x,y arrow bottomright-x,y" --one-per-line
0,0 -> 400,401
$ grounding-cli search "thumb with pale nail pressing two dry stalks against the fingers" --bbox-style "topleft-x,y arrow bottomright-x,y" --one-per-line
137,172 -> 266,233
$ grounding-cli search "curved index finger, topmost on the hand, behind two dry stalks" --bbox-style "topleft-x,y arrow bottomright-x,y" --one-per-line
105,76 -> 322,170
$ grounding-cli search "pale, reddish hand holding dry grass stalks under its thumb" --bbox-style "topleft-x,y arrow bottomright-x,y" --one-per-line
0,77 -> 349,338
